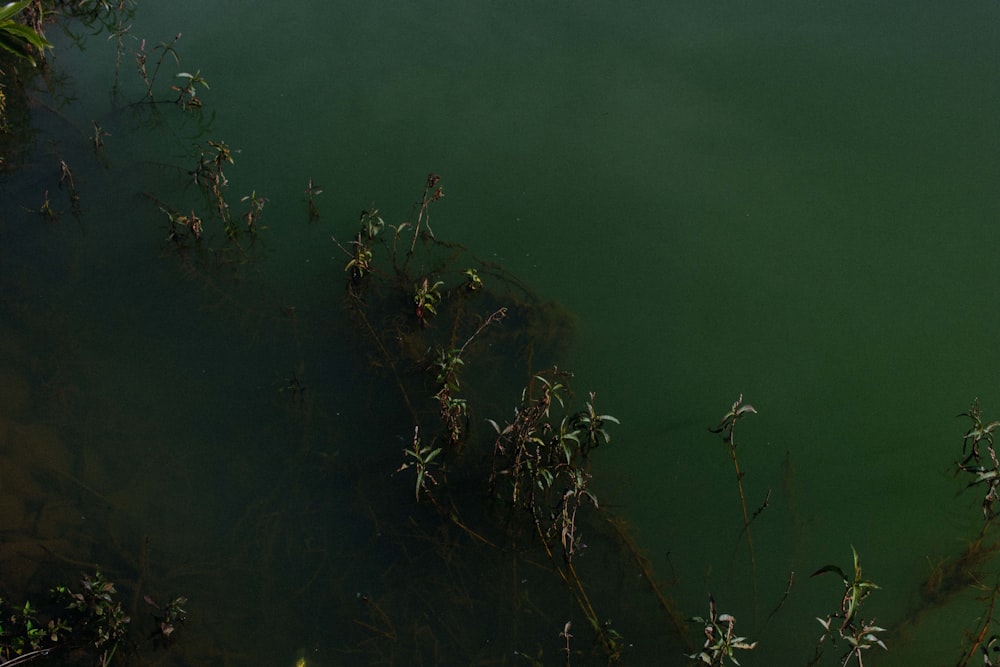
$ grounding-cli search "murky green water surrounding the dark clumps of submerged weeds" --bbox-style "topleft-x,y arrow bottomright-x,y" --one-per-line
0,1 -> 1000,665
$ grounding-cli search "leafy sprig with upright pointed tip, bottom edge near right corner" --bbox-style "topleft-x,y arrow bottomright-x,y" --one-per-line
812,546 -> 888,667
